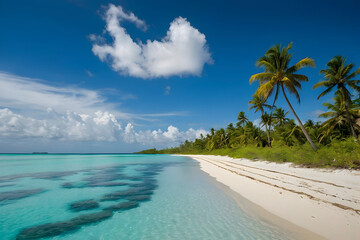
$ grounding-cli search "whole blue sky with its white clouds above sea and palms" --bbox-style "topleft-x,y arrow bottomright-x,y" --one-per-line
0,0 -> 360,152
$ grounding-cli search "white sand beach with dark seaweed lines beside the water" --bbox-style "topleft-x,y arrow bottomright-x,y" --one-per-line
186,155 -> 360,239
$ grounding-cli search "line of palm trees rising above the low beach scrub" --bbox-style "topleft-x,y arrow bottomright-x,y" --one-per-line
139,43 -> 360,156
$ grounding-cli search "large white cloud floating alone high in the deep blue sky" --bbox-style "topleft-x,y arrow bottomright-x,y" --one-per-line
90,4 -> 212,79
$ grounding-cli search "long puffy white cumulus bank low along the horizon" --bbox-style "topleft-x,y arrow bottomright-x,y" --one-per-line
0,108 -> 207,146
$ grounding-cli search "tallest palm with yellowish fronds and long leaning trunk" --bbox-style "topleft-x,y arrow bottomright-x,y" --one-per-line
250,43 -> 317,150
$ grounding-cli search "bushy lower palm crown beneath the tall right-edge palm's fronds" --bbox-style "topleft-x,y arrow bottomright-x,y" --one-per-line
319,95 -> 360,141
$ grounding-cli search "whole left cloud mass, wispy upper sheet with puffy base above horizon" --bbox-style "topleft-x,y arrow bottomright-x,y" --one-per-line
0,72 -> 206,147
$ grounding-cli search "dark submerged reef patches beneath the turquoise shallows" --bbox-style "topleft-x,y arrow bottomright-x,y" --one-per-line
12,164 -> 168,240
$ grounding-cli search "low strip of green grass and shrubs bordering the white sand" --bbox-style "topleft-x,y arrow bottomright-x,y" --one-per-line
139,140 -> 360,169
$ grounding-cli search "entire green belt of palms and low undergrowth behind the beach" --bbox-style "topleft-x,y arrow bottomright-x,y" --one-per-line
140,43 -> 360,168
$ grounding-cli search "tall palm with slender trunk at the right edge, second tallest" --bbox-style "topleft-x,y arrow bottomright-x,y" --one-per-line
313,56 -> 360,141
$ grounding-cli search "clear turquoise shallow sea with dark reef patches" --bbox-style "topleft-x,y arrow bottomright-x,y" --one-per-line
0,154 -> 289,240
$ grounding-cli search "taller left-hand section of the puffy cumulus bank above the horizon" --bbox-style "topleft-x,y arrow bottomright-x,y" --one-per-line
0,108 -> 122,142
